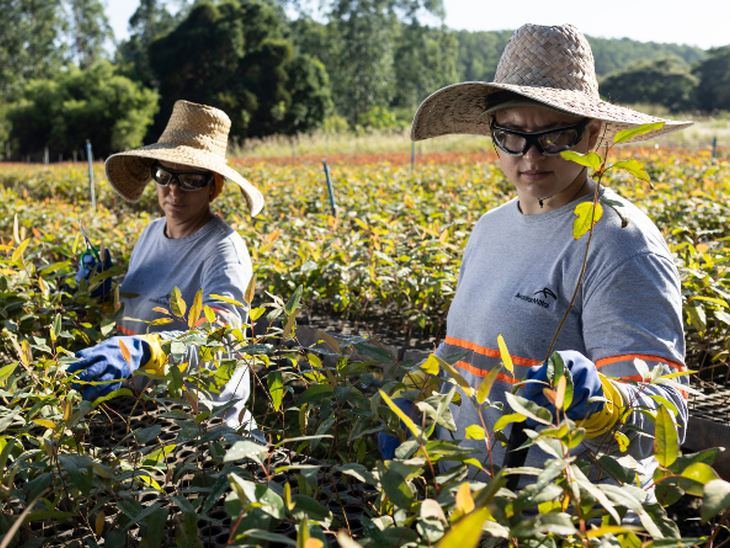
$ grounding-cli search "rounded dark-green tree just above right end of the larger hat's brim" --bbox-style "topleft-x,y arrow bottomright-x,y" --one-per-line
599,57 -> 699,112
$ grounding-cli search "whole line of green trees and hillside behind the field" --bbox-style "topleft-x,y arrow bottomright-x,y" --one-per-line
0,0 -> 730,160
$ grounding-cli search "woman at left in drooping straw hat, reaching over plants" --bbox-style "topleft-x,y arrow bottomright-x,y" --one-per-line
68,101 -> 263,426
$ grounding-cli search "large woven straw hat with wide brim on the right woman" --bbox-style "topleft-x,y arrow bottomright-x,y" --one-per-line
411,24 -> 693,146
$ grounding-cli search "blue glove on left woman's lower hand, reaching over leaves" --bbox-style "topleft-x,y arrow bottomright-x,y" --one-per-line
66,336 -> 151,401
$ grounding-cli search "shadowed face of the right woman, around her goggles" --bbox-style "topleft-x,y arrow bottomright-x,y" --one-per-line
494,106 -> 601,215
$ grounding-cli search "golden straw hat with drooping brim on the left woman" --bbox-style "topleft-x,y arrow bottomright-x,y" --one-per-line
104,101 -> 264,215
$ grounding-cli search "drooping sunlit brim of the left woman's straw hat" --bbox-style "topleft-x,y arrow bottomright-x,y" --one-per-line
104,143 -> 264,216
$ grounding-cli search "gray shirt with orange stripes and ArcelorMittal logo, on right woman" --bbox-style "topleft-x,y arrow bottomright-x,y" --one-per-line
439,185 -> 688,488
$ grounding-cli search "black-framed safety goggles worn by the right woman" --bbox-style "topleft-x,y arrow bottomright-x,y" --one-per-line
490,118 -> 591,156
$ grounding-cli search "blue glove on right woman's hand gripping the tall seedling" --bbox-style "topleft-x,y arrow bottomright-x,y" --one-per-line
522,350 -> 605,421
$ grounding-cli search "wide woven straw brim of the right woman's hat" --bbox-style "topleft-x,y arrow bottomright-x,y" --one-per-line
411,82 -> 694,146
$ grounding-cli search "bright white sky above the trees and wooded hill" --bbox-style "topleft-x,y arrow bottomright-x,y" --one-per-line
106,0 -> 730,49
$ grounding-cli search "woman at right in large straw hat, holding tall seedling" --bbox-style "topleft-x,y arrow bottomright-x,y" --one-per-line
381,25 -> 690,490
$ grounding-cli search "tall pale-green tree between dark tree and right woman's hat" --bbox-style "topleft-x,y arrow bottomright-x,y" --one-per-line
279,0 -> 444,125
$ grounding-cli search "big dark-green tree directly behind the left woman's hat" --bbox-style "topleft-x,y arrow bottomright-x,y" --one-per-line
150,0 -> 331,140
